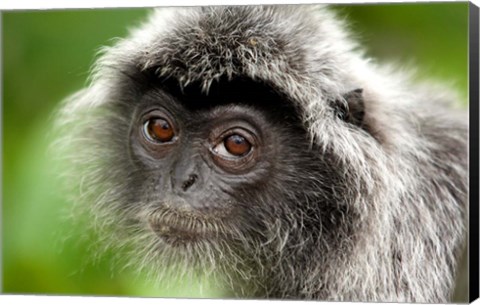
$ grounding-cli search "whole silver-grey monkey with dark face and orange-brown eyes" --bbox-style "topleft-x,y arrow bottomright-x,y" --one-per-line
57,5 -> 468,303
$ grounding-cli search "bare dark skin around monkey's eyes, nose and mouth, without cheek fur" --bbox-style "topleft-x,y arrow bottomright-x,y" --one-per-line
125,82 -> 310,244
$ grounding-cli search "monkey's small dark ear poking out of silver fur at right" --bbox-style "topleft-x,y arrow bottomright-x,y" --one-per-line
335,89 -> 365,126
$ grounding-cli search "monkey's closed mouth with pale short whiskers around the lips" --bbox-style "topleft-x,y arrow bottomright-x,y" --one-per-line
148,205 -> 227,246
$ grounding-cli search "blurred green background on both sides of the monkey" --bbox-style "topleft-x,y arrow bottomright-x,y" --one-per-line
2,3 -> 468,297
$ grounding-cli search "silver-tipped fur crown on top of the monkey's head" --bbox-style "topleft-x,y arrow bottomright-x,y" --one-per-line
99,5 -> 359,102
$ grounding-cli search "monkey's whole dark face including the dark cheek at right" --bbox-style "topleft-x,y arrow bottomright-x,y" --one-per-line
120,80 -> 322,247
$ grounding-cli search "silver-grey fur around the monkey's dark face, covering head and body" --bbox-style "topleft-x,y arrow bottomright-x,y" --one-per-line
58,6 -> 468,302
